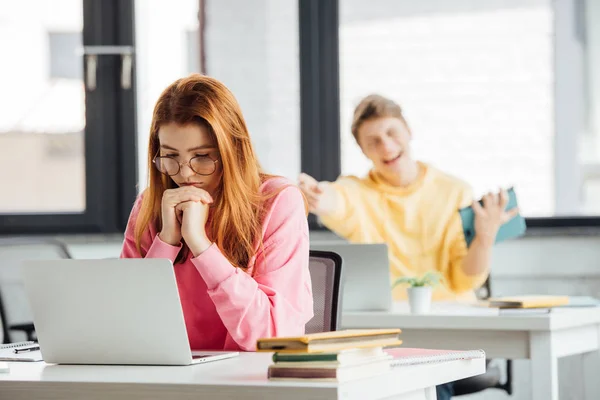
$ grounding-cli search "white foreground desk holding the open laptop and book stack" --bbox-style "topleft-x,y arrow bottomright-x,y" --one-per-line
0,353 -> 485,400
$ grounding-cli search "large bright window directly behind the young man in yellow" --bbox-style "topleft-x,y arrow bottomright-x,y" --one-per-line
339,0 -> 600,222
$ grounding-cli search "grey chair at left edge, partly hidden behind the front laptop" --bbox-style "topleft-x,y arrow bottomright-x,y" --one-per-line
0,238 -> 71,343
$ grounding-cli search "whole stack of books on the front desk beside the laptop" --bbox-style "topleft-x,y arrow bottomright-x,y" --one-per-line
257,329 -> 402,382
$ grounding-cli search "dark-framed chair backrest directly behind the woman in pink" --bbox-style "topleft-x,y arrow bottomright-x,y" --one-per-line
306,250 -> 342,333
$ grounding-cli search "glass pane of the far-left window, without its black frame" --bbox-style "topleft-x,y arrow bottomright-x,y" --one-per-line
0,1 -> 85,213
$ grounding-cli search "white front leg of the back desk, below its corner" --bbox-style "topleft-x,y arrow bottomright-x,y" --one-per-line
529,332 -> 558,400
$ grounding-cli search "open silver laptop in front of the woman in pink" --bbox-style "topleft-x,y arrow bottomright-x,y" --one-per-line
22,258 -> 239,365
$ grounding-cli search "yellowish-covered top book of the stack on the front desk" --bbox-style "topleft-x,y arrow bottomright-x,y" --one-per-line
256,329 -> 402,353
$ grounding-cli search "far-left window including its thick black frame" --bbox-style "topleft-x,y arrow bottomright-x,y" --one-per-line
0,0 -> 136,234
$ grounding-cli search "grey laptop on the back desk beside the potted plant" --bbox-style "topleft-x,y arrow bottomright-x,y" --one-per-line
310,241 -> 392,311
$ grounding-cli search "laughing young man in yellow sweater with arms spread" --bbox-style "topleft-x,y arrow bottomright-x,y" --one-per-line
299,95 -> 518,300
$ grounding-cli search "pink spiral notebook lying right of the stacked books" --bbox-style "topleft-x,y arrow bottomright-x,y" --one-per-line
385,347 -> 485,367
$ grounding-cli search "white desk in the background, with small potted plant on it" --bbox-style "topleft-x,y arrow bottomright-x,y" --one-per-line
342,303 -> 600,400
